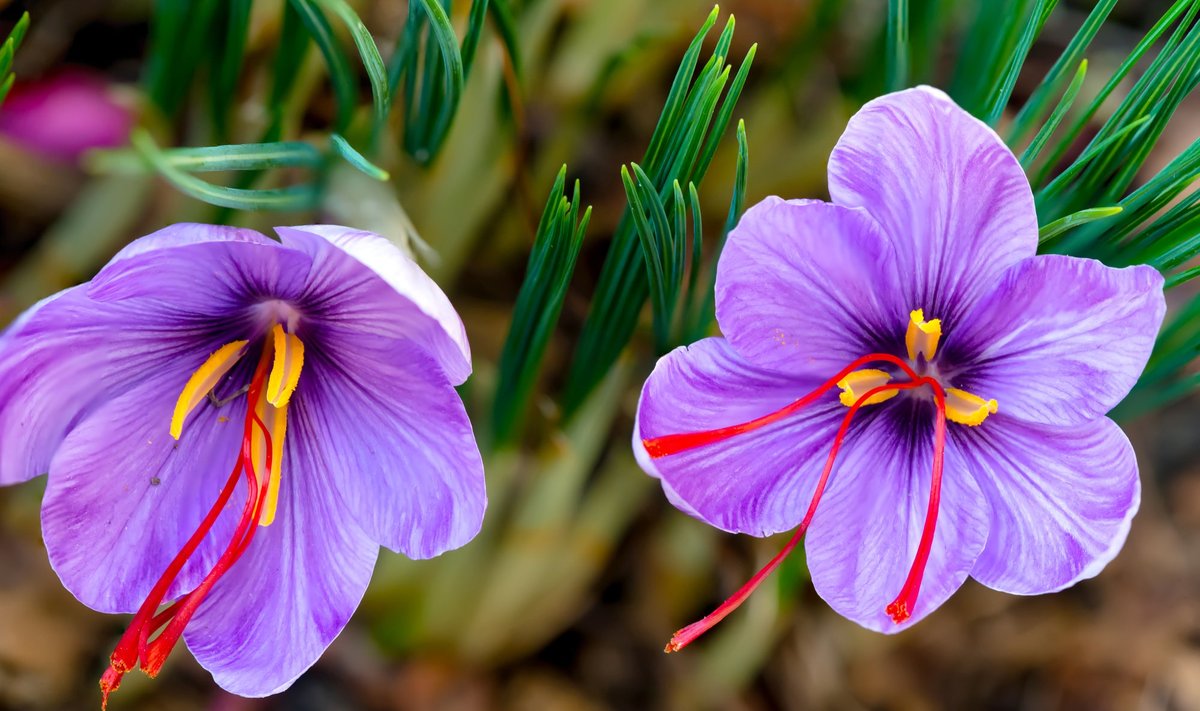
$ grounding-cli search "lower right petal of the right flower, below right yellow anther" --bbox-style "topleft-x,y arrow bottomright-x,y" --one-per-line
958,414 -> 1141,595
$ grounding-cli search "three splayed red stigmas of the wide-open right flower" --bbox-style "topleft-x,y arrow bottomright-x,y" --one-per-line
642,353 -> 946,652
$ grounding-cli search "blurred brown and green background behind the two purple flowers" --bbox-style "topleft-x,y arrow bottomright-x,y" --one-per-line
0,0 -> 1200,711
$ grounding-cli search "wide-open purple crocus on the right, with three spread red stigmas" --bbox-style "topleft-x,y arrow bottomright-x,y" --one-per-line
634,88 -> 1165,651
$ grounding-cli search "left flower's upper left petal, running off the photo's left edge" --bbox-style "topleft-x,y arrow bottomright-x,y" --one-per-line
0,225 -> 311,484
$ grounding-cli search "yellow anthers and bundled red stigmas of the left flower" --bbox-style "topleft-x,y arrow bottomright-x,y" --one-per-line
100,323 -> 304,707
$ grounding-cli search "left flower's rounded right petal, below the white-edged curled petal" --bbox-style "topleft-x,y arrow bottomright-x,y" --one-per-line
294,335 -> 487,558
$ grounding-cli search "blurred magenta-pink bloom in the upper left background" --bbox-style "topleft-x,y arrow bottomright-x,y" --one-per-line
0,70 -> 134,163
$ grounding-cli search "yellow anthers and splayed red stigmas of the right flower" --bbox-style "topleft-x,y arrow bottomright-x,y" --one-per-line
642,309 -> 998,652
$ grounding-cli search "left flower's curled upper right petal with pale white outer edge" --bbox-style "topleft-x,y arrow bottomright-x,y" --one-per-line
276,225 -> 470,386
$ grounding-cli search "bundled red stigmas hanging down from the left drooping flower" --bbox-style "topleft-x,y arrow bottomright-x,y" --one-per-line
100,351 -> 272,709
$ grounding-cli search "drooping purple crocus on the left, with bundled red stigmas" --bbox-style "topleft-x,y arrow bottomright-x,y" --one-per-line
0,225 -> 486,700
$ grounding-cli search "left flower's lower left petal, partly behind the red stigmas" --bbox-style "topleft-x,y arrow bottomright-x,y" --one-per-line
42,372 -> 245,613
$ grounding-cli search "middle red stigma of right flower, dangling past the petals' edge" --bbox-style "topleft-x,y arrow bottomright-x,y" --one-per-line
664,379 -> 944,653
